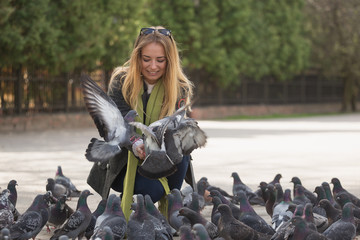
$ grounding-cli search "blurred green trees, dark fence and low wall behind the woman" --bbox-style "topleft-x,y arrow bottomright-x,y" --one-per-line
0,0 -> 360,130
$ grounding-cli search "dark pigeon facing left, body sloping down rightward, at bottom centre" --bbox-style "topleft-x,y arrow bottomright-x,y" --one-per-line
179,207 -> 218,239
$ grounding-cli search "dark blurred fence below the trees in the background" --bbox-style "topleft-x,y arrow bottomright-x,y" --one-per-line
0,73 -> 343,116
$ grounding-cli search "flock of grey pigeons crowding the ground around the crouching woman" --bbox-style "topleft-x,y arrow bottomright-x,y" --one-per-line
0,166 -> 360,240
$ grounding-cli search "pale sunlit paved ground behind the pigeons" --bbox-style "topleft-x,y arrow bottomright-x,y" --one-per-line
0,114 -> 360,239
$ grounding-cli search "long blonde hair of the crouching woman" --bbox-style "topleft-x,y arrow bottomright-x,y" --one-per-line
110,26 -> 193,118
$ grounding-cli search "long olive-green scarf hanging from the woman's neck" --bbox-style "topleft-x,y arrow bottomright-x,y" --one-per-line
121,80 -> 170,221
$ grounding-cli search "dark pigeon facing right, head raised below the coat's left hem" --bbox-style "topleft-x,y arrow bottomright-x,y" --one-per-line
50,189 -> 93,240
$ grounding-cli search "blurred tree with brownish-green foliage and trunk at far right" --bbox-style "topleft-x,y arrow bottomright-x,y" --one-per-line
306,0 -> 360,112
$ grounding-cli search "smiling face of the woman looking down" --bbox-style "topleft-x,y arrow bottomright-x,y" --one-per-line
141,42 -> 166,84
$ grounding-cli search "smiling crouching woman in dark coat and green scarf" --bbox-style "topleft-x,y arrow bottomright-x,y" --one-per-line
88,26 -> 194,219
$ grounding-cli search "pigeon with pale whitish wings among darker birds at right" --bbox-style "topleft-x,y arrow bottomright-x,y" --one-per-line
271,189 -> 293,230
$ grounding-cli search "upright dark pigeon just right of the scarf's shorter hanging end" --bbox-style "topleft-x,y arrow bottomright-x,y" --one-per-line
166,188 -> 184,232
